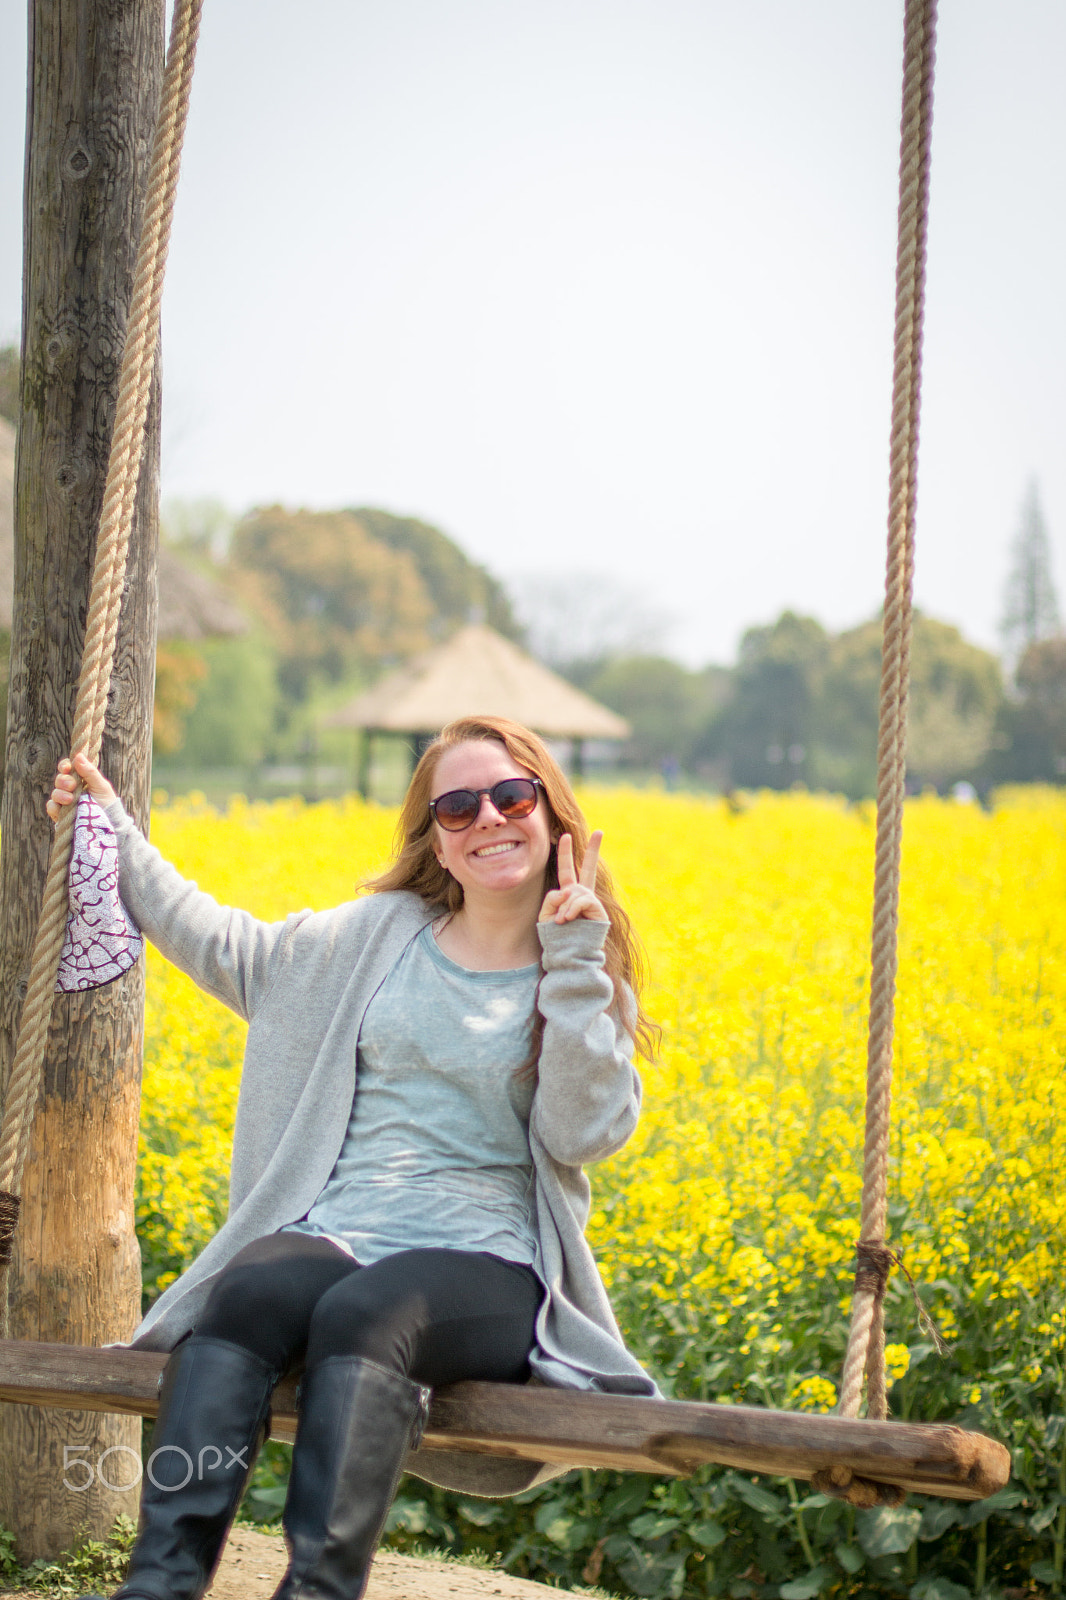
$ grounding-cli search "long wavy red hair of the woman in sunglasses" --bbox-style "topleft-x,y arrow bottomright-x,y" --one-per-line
367,717 -> 659,1061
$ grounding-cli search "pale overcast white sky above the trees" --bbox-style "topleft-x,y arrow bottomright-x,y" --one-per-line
0,0 -> 1066,664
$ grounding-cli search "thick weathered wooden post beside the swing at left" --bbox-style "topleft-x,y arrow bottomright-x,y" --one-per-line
0,0 -> 163,1560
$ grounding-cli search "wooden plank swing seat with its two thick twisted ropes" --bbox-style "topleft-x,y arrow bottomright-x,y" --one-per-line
0,0 -> 1010,1506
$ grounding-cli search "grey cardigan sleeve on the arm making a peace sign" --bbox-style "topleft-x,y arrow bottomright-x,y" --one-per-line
530,917 -> 640,1166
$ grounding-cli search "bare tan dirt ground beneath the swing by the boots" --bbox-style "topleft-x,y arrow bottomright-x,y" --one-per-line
0,1526 -> 589,1600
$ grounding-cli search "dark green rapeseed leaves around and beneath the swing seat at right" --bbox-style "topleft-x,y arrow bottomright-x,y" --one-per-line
369,1285 -> 1066,1600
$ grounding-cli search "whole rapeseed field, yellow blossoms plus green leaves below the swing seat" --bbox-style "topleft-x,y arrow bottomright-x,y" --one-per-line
138,789 -> 1066,1600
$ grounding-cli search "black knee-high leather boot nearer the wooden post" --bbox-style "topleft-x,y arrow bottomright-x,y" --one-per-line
85,1334 -> 279,1600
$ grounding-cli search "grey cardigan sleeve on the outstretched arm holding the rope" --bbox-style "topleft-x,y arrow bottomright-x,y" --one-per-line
104,800 -> 294,1021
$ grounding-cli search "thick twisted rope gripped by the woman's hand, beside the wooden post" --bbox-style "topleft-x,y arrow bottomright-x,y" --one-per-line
0,0 -> 203,1336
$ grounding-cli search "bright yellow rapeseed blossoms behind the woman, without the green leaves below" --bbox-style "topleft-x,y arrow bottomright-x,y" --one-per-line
141,789 -> 1066,1408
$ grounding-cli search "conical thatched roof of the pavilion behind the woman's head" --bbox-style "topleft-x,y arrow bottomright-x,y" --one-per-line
327,626 -> 629,739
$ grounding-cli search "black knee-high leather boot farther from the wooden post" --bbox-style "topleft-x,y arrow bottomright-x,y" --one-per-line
274,1355 -> 429,1600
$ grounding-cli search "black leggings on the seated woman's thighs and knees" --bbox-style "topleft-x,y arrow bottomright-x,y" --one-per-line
195,1234 -> 543,1389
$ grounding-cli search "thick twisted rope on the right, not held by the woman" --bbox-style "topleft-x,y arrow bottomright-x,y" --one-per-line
839,0 -> 936,1452
